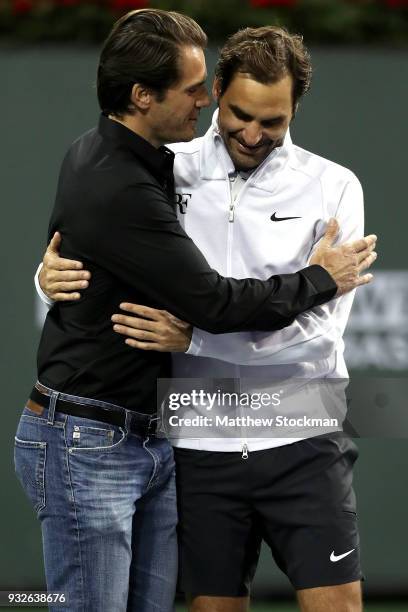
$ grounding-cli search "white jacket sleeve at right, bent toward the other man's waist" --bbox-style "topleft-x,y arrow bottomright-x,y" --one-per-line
187,176 -> 364,366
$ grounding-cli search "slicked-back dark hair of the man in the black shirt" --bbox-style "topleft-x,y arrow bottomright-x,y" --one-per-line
97,9 -> 207,117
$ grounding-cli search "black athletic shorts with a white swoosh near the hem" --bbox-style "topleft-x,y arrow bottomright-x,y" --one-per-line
175,433 -> 362,597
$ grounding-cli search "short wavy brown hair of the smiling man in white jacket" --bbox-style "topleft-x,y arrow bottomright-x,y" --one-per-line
215,26 -> 312,108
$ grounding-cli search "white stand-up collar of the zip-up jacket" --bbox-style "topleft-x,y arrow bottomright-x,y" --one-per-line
200,109 -> 293,187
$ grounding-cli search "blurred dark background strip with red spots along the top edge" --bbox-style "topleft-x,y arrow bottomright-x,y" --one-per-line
0,0 -> 408,46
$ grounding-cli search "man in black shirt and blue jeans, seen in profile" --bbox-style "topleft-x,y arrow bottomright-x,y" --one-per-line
16,10 -> 374,612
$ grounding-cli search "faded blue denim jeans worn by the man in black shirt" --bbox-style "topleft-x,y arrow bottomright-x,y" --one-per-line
15,384 -> 177,612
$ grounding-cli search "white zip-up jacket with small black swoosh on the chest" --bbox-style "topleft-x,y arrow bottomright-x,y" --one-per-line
167,112 -> 364,451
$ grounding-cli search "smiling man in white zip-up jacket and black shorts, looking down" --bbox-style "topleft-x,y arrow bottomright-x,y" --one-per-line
37,27 -> 372,612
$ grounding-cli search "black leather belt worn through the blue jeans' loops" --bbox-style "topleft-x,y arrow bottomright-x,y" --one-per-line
26,383 -> 157,437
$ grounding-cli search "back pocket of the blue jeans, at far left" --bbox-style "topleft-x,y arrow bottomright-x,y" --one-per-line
14,437 -> 47,513
